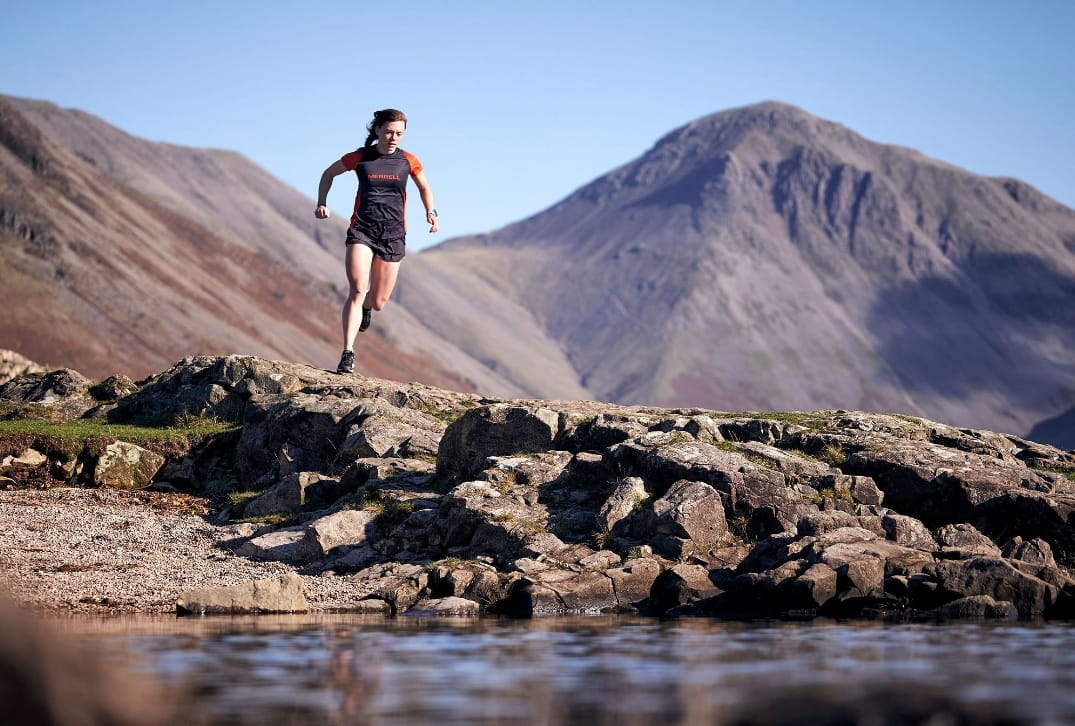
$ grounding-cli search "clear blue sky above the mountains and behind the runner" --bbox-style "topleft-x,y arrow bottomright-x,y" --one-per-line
0,0 -> 1075,248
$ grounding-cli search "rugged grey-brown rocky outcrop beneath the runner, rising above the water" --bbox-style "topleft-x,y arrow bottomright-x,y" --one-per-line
0,356 -> 1075,618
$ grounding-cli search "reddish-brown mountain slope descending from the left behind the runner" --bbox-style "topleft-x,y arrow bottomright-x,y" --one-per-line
0,97 -> 473,390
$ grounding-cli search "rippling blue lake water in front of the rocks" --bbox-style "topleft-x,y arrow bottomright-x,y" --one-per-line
52,615 -> 1075,726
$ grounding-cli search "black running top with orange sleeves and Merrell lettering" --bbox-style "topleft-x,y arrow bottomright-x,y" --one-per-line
340,146 -> 421,240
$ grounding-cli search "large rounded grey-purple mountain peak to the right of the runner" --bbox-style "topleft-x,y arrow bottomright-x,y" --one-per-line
398,102 -> 1075,443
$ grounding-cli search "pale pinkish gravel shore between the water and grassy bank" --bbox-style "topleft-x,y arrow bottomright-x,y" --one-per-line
0,488 -> 364,613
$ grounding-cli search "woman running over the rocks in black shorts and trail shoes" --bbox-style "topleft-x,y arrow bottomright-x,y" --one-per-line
314,109 -> 439,373
